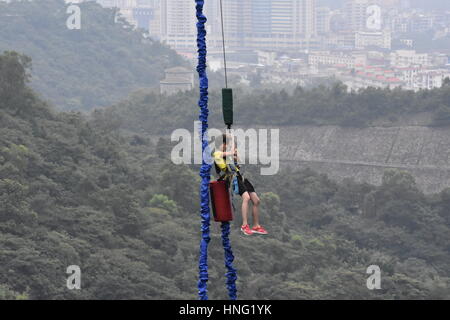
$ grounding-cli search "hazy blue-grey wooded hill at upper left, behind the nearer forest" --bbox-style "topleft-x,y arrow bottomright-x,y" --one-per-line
0,0 -> 185,110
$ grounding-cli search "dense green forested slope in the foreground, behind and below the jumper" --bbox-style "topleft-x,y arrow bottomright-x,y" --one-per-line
0,52 -> 450,299
